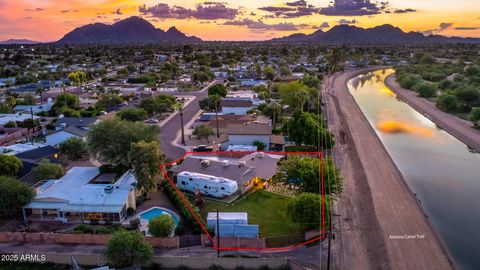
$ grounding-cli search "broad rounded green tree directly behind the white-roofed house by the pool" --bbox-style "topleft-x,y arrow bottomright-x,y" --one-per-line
87,119 -> 158,168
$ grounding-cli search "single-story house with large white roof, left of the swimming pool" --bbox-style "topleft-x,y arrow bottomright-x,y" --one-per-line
23,167 -> 137,223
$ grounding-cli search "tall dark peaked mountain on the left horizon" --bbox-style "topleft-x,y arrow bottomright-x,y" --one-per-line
56,16 -> 202,44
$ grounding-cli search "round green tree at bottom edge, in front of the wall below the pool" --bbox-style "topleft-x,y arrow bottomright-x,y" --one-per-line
104,230 -> 153,268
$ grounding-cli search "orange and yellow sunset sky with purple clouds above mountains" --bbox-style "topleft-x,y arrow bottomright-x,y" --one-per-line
0,0 -> 480,41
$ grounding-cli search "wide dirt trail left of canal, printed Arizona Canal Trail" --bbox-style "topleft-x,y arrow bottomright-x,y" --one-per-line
324,71 -> 454,269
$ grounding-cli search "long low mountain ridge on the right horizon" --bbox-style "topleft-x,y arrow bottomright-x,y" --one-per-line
269,24 -> 480,44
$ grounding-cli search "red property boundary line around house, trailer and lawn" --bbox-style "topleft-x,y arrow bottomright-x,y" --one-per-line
160,151 -> 326,252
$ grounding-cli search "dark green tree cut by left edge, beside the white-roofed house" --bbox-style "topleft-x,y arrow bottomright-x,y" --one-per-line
0,176 -> 35,217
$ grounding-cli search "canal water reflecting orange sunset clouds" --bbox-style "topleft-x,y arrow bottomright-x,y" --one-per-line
348,69 -> 480,270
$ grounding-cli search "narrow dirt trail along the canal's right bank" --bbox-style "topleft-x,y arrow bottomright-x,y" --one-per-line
385,74 -> 480,153
